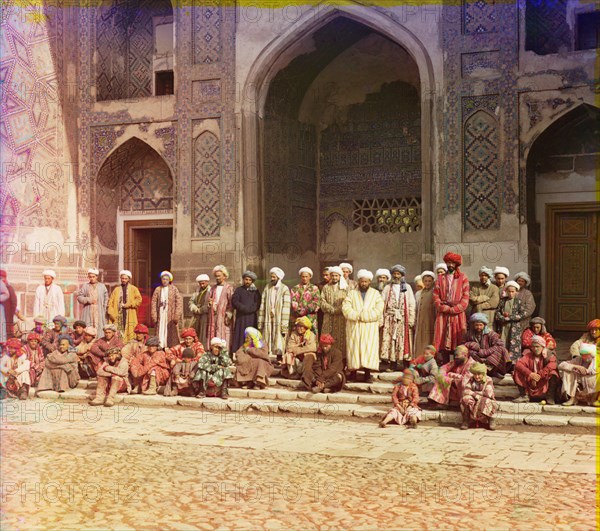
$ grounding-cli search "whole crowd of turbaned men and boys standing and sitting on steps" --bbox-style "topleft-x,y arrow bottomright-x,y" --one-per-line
0,253 -> 600,429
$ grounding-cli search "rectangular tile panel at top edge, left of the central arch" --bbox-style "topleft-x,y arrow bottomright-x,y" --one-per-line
192,1 -> 223,64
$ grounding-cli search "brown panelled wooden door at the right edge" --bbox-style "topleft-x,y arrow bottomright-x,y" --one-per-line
546,203 -> 600,331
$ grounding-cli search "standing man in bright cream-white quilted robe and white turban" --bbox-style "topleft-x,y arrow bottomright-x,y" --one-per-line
342,269 -> 384,383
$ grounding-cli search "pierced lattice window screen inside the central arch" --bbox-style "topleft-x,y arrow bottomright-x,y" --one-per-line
352,197 -> 421,233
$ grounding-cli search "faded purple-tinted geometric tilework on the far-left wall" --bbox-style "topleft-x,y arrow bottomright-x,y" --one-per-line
0,0 -> 70,229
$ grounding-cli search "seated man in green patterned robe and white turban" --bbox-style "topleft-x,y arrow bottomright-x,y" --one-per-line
194,337 -> 233,400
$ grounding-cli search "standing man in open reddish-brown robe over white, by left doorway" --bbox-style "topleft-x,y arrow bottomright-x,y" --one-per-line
150,271 -> 183,349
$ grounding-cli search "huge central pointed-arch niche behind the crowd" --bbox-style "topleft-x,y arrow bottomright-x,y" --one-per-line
242,8 -> 435,271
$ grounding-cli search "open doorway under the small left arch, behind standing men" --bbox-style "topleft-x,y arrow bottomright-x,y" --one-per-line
125,220 -> 173,326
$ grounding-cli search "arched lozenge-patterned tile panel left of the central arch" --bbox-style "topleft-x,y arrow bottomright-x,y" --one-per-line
193,131 -> 221,238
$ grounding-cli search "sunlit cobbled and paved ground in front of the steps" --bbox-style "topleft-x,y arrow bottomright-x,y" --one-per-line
0,402 -> 596,531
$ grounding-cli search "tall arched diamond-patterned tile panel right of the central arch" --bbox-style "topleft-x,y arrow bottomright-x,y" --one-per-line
463,110 -> 500,231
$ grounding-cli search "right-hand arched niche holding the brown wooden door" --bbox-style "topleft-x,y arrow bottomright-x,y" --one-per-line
526,103 -> 600,335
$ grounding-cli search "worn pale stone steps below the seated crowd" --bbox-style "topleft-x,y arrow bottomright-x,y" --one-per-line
9,388 -> 597,428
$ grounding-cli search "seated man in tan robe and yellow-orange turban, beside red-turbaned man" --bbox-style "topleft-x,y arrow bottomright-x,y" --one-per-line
281,316 -> 317,390
